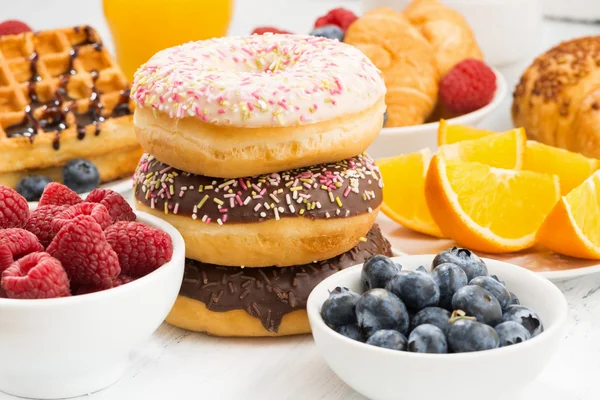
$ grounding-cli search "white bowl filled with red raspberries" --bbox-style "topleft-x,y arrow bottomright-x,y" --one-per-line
0,183 -> 185,399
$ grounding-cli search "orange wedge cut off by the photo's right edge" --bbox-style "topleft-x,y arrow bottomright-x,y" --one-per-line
537,172 -> 600,260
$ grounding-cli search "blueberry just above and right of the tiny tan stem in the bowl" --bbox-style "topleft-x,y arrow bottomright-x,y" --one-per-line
452,285 -> 502,326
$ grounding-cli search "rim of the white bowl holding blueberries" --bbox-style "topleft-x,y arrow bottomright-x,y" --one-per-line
306,254 -> 568,362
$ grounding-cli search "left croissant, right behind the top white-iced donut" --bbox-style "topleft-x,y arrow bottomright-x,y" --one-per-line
344,8 -> 439,127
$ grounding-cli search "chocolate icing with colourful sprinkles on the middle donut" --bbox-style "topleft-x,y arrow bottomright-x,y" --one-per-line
134,154 -> 383,225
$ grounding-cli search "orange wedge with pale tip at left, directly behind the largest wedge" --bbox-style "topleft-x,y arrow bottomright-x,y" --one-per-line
438,129 -> 527,169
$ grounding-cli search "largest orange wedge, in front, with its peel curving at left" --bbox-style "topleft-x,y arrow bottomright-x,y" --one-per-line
425,155 -> 560,253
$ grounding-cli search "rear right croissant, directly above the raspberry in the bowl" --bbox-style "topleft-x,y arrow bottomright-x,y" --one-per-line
403,0 -> 483,76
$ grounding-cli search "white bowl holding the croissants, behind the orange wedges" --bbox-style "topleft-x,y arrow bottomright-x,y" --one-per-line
367,69 -> 507,159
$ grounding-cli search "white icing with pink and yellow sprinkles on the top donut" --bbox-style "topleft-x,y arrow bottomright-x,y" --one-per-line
131,34 -> 386,127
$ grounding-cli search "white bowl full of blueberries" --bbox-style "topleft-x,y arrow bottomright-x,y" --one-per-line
307,247 -> 567,400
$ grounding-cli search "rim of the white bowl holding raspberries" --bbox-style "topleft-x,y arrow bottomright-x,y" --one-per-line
0,210 -> 185,310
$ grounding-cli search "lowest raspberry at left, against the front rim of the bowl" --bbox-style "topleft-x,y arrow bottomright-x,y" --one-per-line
1,252 -> 71,299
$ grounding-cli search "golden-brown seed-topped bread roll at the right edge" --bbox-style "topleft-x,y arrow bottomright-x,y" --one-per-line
512,36 -> 600,158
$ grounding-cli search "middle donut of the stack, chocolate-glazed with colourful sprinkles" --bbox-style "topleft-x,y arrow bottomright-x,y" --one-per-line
134,154 -> 383,268
